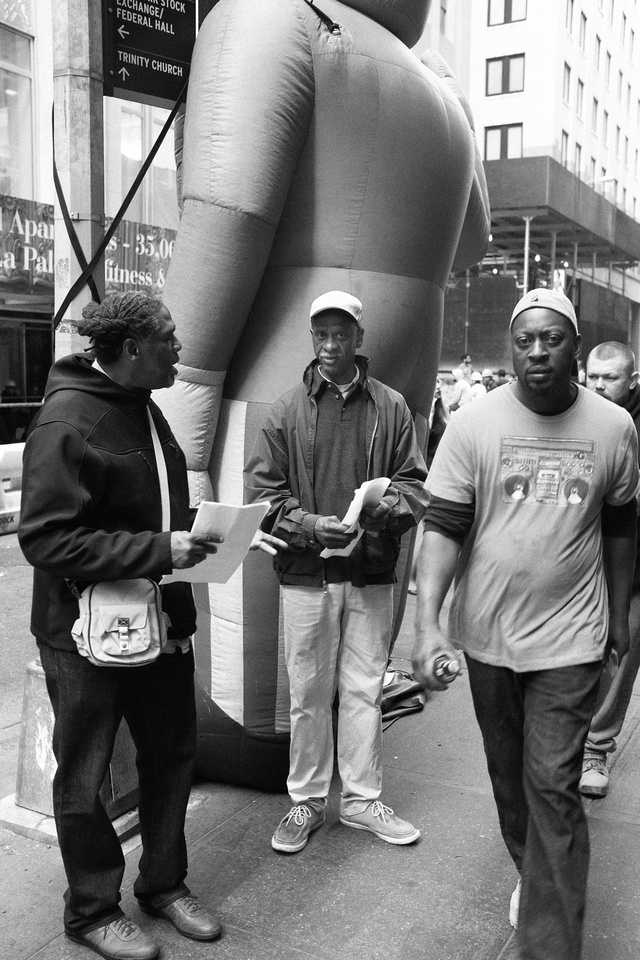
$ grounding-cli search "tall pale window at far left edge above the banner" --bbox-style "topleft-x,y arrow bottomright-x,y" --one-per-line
0,26 -> 35,200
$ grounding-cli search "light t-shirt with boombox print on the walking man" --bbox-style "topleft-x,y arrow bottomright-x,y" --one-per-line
425,385 -> 638,671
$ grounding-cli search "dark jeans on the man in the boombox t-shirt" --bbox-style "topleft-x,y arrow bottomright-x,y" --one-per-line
466,657 -> 602,960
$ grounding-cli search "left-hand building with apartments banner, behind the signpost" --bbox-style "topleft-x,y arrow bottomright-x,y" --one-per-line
0,0 -> 179,442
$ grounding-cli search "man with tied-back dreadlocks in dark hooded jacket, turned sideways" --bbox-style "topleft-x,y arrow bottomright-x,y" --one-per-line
19,293 -> 221,960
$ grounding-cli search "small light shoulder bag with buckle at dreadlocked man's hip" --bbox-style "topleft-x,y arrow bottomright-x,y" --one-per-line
71,577 -> 169,667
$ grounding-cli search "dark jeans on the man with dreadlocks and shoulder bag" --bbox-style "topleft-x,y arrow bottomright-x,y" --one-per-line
40,645 -> 196,933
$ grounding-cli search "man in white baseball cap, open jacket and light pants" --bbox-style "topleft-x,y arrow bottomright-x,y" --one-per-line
245,290 -> 426,853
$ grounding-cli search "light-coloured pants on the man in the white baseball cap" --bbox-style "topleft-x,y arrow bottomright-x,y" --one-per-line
282,583 -> 393,814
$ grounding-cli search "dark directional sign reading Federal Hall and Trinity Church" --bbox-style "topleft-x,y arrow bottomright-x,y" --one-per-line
102,0 -> 196,107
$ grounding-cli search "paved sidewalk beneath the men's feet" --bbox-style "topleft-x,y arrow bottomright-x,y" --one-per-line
0,528 -> 640,960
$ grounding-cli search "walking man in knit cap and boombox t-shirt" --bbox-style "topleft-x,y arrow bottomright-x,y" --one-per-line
414,289 -> 638,960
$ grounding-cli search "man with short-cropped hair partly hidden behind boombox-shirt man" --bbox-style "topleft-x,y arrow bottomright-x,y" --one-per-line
580,340 -> 640,797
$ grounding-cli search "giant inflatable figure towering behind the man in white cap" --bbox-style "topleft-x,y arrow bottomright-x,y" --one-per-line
157,0 -> 489,790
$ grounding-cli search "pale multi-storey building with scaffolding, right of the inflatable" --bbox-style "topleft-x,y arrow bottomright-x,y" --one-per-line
423,0 -> 640,374
